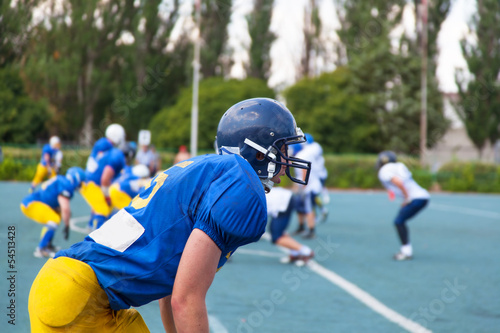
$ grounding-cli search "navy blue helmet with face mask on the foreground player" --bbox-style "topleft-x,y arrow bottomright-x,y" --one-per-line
216,98 -> 311,192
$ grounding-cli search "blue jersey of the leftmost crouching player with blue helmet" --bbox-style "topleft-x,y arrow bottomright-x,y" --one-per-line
22,176 -> 73,209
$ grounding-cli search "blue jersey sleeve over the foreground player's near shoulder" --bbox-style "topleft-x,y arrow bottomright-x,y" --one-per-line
194,166 -> 267,252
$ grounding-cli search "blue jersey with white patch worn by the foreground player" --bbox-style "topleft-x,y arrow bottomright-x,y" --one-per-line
56,155 -> 267,310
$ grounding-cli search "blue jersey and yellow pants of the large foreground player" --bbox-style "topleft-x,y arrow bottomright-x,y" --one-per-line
29,155 -> 267,332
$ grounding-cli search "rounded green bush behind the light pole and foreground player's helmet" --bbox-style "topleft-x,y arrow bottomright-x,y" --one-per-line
150,78 -> 274,150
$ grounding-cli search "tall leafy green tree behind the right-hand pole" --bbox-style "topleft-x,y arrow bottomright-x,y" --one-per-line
339,0 -> 448,154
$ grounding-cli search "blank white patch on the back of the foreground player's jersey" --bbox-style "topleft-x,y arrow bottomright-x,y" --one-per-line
89,209 -> 144,252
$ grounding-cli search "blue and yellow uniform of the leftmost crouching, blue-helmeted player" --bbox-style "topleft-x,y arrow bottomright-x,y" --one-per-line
21,176 -> 74,254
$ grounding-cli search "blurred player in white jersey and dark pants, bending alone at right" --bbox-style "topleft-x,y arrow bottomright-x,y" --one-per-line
377,151 -> 430,260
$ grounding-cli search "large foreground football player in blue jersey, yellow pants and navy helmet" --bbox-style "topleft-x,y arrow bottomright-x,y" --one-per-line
29,98 -> 311,332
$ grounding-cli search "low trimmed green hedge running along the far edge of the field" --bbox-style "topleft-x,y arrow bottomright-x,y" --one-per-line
0,147 -> 500,193
